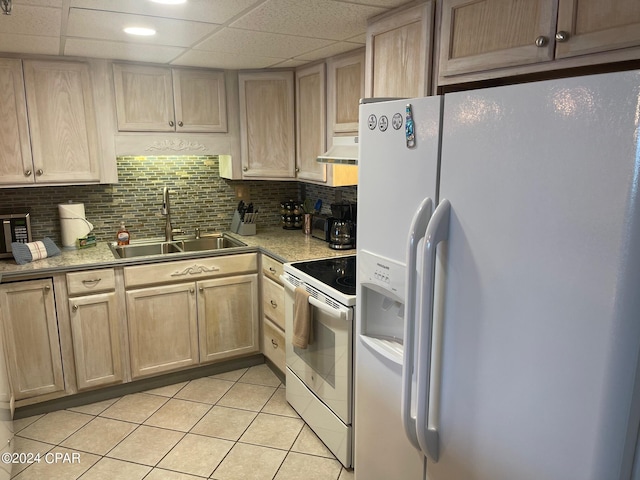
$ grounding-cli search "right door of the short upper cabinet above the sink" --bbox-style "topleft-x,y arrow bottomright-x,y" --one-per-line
172,68 -> 227,132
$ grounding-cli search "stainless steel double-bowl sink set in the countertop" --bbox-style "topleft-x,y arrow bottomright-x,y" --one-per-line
109,234 -> 246,258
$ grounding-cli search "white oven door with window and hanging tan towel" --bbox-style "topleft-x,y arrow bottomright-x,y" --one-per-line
284,280 -> 354,425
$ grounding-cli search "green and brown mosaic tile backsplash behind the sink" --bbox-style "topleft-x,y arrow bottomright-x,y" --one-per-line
0,156 -> 357,245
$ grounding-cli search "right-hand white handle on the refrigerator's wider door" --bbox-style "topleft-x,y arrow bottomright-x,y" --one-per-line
416,199 -> 451,462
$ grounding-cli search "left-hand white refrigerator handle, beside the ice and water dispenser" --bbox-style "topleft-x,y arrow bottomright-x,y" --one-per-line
400,197 -> 433,450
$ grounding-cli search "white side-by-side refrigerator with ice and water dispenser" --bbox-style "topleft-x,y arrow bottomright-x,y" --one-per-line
354,71 -> 640,480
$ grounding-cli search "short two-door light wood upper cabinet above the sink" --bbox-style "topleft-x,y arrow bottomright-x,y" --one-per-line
113,64 -> 227,133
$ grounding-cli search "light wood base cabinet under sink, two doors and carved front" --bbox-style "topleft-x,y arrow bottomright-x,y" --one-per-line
124,253 -> 260,379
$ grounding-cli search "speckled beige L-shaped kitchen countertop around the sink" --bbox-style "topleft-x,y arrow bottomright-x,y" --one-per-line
0,227 -> 356,283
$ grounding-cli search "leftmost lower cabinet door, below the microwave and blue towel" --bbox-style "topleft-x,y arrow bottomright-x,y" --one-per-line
0,279 -> 64,400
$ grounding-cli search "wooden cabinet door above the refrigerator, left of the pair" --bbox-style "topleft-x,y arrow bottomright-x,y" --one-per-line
438,0 -> 556,76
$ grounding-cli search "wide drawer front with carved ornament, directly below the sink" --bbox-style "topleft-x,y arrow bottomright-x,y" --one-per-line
124,253 -> 258,288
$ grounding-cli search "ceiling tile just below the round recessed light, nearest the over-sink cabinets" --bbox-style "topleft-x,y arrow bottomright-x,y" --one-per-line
64,38 -> 185,63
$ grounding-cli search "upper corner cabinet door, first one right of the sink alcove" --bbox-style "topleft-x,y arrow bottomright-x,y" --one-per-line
238,72 -> 295,178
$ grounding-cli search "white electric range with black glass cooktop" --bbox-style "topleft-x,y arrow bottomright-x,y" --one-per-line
281,255 -> 356,467
